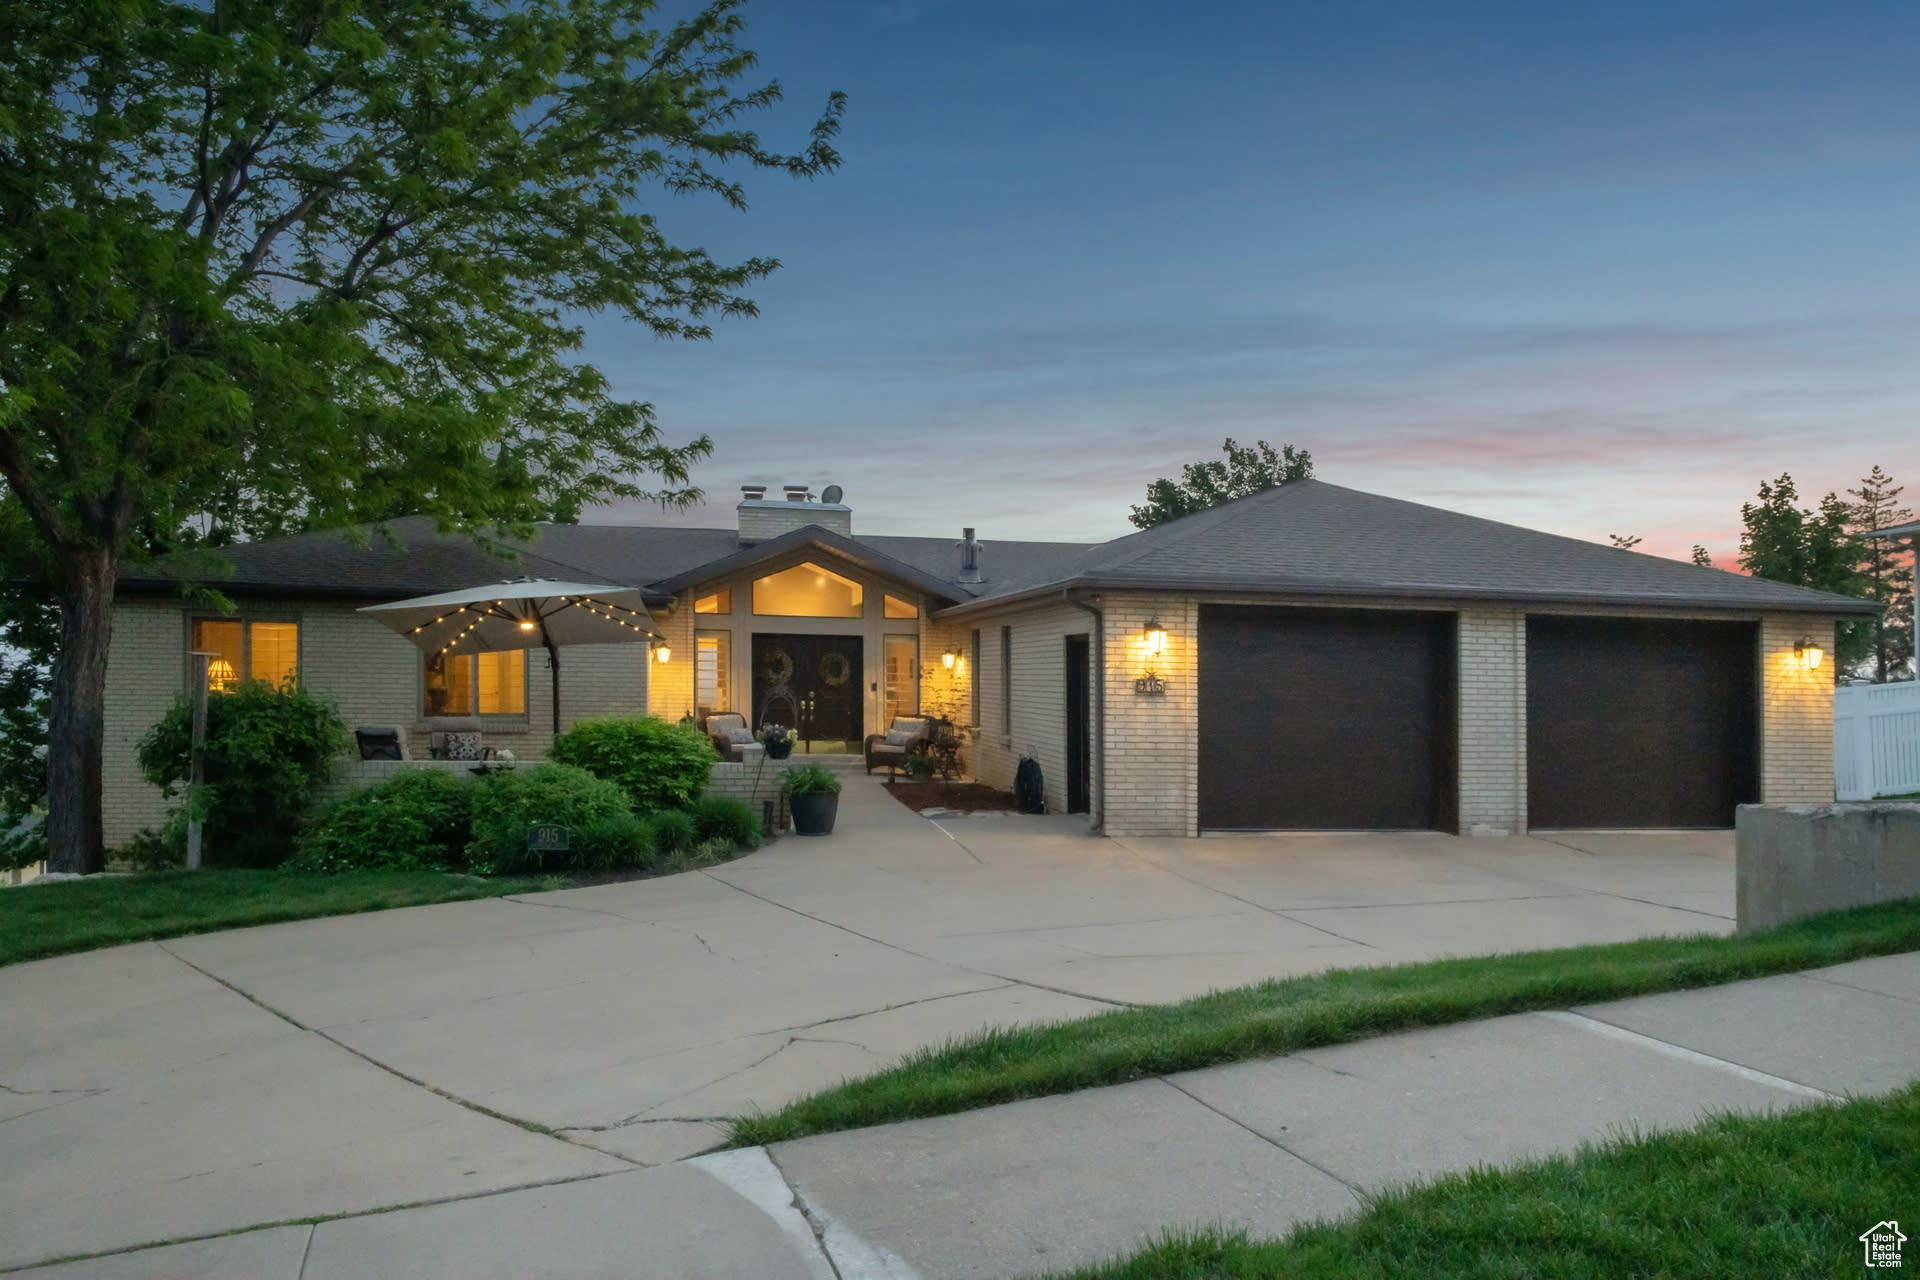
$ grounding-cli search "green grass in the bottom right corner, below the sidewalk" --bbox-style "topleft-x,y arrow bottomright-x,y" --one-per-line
1064,1084 -> 1920,1280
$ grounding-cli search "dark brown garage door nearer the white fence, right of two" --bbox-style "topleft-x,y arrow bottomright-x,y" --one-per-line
1526,618 -> 1759,827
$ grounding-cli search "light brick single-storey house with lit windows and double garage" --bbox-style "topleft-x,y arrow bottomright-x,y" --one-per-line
106,480 -> 1874,842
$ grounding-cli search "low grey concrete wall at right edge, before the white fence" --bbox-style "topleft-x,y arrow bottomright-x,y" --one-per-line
1734,802 -> 1920,933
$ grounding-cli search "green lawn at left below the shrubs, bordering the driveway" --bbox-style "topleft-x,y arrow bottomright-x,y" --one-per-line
0,871 -> 563,965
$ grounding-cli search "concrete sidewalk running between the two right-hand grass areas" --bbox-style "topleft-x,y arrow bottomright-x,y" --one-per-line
19,954 -> 1920,1280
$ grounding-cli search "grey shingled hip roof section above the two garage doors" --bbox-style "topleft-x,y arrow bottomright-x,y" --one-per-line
950,480 -> 1876,614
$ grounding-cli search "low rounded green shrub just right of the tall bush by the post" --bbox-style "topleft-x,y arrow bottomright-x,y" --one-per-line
284,770 -> 472,871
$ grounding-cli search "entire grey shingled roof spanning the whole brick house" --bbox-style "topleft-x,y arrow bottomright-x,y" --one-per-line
123,480 -> 1876,614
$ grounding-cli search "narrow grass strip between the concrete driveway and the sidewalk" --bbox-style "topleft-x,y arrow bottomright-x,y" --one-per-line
730,898 -> 1920,1146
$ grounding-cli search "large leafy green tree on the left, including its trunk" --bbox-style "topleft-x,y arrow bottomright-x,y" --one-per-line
0,0 -> 841,871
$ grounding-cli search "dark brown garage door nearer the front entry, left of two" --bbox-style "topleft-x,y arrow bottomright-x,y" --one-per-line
1200,604 -> 1457,831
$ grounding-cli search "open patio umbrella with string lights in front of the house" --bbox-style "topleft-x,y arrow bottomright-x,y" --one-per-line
359,578 -> 666,733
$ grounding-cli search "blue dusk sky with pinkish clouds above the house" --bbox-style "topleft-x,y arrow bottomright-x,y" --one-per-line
588,0 -> 1920,558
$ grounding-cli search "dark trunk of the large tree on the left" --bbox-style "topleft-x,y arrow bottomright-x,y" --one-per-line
46,551 -> 119,873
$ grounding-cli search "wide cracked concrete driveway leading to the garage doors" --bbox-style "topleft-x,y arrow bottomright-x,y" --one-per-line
0,781 -> 1734,1274
